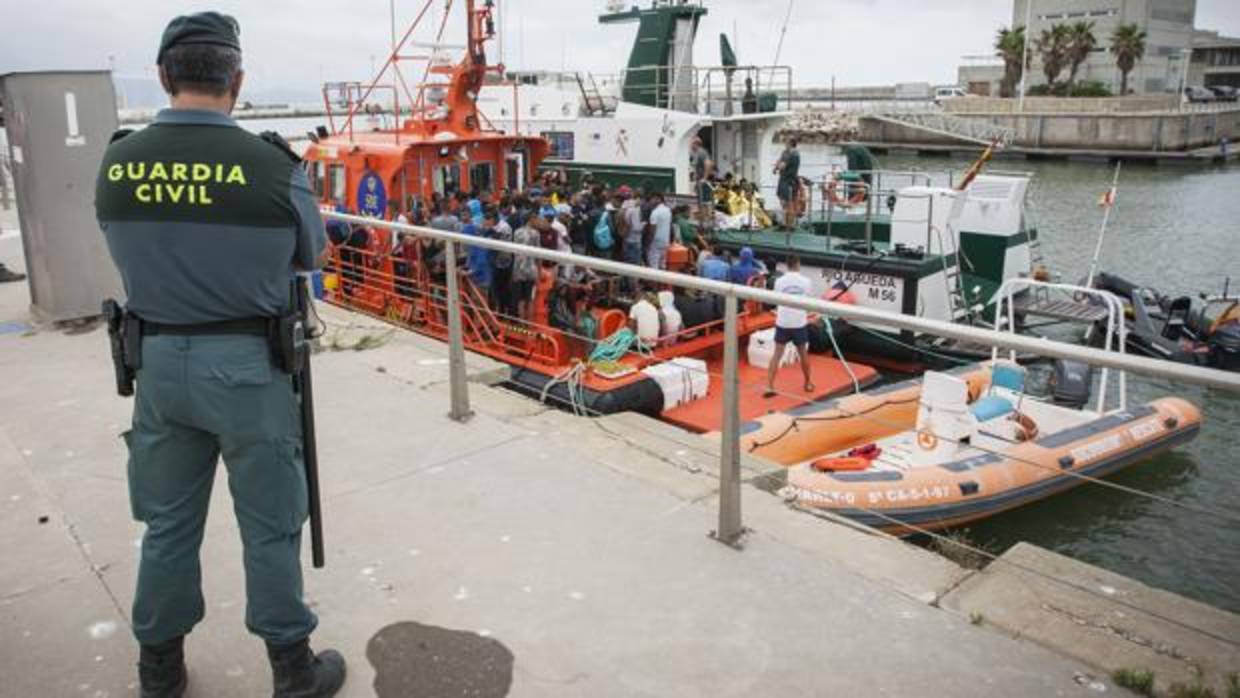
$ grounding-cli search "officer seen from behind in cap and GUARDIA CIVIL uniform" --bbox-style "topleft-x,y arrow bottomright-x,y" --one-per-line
95,12 -> 345,698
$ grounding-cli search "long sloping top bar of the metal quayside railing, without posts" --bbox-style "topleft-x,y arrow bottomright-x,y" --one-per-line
324,211 -> 1240,392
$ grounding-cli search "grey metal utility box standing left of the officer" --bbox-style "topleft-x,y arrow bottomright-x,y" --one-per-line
0,71 -> 123,322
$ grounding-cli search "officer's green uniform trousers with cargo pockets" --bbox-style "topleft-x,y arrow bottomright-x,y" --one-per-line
125,335 -> 317,645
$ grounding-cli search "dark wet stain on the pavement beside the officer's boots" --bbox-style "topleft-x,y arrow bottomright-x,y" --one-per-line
366,621 -> 513,698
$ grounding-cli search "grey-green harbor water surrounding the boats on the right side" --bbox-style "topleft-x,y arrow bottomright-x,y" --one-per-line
879,156 -> 1240,612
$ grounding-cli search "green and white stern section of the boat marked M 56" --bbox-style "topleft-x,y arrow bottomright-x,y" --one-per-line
714,170 -> 1042,372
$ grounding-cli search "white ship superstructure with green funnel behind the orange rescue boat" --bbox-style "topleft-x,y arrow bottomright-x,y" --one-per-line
477,0 -> 803,196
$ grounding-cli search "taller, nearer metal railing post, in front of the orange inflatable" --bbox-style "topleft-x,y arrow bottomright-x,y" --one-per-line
714,294 -> 744,546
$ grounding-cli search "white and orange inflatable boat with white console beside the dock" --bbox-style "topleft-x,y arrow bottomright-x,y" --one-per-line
783,362 -> 1202,534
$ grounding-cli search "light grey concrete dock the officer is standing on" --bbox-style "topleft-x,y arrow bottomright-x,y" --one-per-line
0,212 -> 1240,698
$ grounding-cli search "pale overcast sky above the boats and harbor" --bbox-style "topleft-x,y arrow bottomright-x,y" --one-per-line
7,0 -> 1240,99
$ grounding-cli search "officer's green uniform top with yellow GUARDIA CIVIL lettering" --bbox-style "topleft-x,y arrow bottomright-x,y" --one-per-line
95,109 -> 326,325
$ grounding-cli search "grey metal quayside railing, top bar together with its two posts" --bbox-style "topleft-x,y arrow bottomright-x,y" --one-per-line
324,212 -> 1240,544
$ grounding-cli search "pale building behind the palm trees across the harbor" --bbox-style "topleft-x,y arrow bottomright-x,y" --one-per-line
959,0 -> 1200,95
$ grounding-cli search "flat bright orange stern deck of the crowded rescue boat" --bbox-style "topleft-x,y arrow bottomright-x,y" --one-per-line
662,353 -> 879,433
